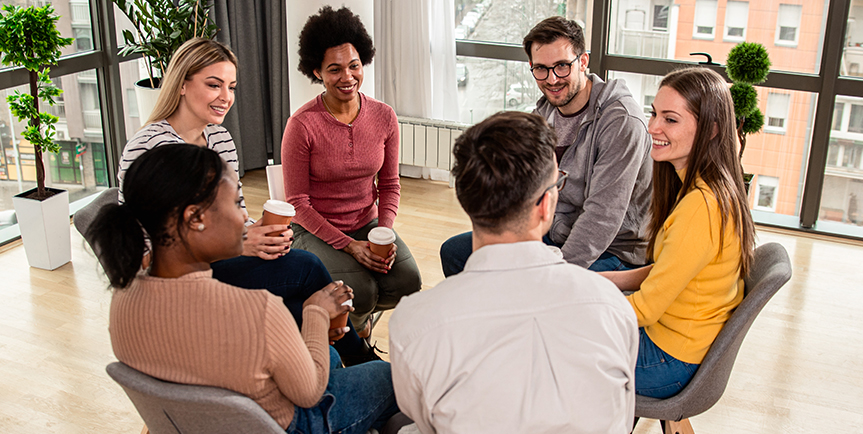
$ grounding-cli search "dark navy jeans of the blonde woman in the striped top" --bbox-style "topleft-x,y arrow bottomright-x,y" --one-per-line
210,249 -> 368,356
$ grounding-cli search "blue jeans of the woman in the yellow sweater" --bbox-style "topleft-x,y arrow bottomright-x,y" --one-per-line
635,327 -> 699,399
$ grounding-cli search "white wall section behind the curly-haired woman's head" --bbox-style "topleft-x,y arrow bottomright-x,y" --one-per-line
286,0 -> 375,115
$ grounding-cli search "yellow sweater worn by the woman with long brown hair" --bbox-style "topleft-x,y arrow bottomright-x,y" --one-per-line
627,171 -> 743,364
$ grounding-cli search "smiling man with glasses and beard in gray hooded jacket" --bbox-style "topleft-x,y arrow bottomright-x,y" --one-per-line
440,17 -> 653,276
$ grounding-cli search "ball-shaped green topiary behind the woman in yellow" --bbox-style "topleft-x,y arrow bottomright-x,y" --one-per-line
725,42 -> 770,192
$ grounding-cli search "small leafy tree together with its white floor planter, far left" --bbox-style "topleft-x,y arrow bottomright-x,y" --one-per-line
0,5 -> 72,270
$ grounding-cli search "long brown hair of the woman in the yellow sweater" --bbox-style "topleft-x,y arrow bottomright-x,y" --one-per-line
647,67 -> 755,276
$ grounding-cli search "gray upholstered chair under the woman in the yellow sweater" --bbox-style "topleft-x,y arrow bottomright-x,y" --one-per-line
635,243 -> 791,434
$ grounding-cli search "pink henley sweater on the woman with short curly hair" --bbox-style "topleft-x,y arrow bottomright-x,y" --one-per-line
282,93 -> 400,250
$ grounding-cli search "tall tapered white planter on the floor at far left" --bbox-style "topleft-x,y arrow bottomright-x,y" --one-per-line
12,188 -> 72,270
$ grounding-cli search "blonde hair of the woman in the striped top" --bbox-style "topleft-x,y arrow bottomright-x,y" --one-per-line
144,38 -> 237,126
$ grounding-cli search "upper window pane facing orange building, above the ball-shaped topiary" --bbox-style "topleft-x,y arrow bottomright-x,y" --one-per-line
608,0 -> 824,73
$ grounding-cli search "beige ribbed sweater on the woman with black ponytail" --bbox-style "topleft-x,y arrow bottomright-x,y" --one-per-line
109,270 -> 329,428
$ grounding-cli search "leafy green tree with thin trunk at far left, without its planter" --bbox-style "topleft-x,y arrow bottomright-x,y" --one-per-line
0,5 -> 73,200
